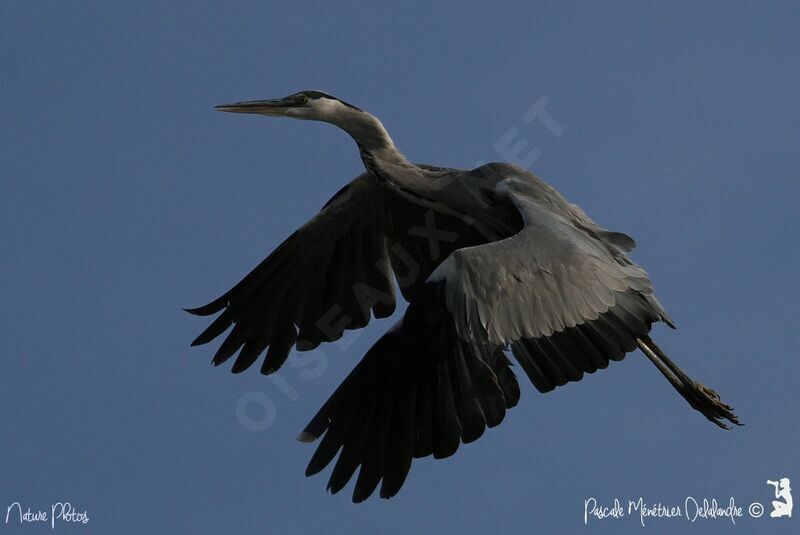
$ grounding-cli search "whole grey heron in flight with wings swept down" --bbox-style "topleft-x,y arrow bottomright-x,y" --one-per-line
188,91 -> 740,502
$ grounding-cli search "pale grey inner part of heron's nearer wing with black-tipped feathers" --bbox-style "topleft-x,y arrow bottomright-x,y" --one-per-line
429,178 -> 672,392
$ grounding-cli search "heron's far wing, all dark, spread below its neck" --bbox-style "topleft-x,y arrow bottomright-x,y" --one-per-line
188,173 -> 395,374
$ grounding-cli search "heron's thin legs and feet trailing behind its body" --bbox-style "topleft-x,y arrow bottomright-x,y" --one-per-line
636,335 -> 744,429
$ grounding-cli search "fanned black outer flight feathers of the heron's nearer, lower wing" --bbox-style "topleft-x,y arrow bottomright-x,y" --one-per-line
297,307 -> 519,502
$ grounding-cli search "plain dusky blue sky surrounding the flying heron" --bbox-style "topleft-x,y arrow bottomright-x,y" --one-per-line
0,1 -> 800,534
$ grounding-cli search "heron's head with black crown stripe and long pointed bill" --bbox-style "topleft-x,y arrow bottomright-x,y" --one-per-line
215,91 -> 361,124
